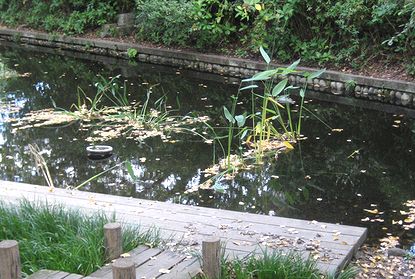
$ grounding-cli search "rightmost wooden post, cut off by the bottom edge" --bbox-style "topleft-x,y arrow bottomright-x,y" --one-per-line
202,237 -> 220,279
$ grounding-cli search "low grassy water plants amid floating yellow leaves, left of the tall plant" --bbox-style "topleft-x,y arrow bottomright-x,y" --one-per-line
11,76 -> 209,142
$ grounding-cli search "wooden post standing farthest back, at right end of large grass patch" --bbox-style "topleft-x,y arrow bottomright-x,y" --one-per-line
104,223 -> 122,261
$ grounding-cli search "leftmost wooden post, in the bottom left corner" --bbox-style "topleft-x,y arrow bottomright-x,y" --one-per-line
0,240 -> 22,279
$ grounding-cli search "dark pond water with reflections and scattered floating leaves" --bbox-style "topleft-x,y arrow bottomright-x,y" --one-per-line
0,45 -> 415,245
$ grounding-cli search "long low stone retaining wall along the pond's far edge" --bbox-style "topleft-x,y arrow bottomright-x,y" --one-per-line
0,28 -> 415,108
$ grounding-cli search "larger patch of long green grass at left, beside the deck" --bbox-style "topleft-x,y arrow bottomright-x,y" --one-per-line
0,201 -> 159,275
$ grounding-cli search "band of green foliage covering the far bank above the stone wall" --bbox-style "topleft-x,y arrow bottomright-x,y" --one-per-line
0,0 -> 415,76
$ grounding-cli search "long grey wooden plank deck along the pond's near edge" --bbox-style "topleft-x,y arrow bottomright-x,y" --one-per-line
0,181 -> 367,272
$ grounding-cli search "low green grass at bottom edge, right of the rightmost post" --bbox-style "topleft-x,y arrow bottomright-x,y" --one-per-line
214,251 -> 356,279
